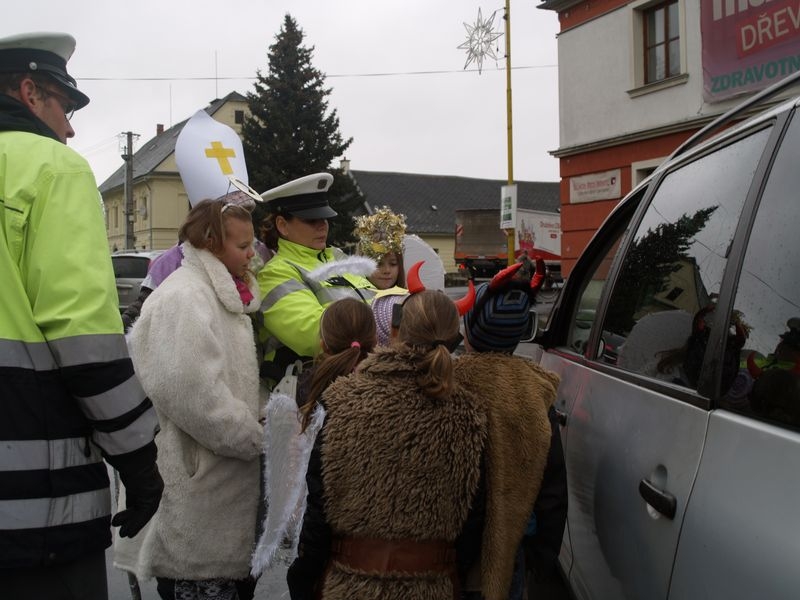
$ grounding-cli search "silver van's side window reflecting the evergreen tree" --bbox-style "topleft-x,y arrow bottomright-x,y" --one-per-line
599,128 -> 769,389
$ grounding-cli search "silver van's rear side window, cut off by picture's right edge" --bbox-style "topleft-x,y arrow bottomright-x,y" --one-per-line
721,114 -> 800,427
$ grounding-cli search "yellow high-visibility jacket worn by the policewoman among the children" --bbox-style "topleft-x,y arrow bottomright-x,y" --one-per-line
258,239 -> 375,360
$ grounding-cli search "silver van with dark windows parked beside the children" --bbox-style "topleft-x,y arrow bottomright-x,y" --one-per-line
536,73 -> 800,600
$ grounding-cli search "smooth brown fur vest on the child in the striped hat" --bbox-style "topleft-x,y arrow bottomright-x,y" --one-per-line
456,352 -> 559,600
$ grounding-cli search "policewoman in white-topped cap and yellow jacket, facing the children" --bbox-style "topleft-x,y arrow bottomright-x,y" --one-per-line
258,173 -> 375,381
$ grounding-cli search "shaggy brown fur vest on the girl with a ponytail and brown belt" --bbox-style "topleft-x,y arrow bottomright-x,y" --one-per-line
322,348 -> 486,600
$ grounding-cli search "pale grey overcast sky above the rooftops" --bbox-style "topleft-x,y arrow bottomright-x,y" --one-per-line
0,0 -> 558,183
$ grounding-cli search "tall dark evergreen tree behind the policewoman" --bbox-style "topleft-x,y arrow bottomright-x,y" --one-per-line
242,14 -> 362,245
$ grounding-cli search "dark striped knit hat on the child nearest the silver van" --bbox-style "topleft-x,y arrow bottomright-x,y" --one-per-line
464,283 -> 531,352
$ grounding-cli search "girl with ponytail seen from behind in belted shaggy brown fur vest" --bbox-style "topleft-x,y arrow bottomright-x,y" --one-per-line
287,291 -> 486,600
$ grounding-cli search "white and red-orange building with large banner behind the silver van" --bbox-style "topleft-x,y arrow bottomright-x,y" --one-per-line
539,0 -> 800,274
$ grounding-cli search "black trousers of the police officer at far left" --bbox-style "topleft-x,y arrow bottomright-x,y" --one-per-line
0,551 -> 108,600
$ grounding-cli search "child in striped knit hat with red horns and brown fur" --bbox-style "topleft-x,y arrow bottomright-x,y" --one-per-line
456,259 -> 567,600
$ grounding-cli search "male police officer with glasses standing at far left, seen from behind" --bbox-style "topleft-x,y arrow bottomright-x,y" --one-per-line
0,33 -> 163,600
